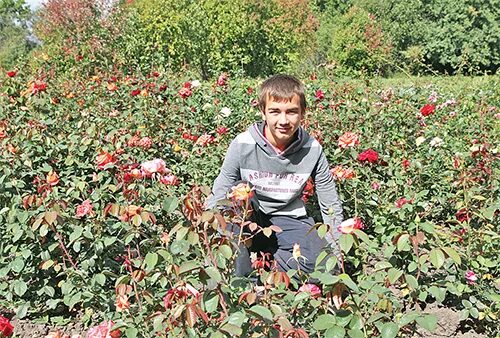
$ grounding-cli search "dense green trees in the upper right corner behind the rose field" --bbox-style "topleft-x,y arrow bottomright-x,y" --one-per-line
355,0 -> 500,73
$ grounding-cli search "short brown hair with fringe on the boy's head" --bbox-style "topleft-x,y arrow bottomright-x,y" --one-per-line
259,74 -> 307,114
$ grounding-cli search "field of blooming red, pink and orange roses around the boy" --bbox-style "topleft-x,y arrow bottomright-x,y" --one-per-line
0,64 -> 500,338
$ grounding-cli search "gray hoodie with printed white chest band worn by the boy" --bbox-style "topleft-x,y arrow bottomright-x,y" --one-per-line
207,121 -> 343,242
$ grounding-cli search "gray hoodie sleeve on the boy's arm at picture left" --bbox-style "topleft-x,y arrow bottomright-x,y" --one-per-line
207,139 -> 241,209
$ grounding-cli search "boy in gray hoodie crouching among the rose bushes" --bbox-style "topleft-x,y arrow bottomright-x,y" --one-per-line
207,75 -> 342,276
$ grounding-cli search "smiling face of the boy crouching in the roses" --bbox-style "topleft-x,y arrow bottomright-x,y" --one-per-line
262,95 -> 304,150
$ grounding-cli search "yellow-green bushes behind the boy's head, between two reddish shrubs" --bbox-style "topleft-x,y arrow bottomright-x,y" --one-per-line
130,0 -> 315,78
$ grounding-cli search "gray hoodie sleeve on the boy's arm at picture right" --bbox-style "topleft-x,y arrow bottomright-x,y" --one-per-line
313,148 -> 343,245
